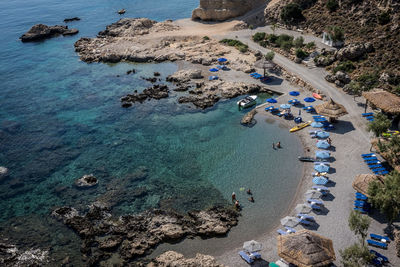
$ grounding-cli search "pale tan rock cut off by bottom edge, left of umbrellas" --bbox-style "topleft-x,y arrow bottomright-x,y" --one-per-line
152,251 -> 224,267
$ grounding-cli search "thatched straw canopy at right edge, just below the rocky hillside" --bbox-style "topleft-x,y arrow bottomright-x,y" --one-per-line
362,89 -> 400,114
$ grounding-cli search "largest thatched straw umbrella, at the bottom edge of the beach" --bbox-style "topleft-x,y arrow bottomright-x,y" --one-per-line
278,230 -> 336,267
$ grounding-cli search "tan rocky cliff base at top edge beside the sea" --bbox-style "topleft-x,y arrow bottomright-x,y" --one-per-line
192,0 -> 268,21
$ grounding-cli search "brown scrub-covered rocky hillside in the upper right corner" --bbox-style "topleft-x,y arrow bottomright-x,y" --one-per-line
264,0 -> 400,93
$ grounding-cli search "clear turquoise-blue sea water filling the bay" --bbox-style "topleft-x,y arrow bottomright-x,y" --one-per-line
0,0 -> 301,264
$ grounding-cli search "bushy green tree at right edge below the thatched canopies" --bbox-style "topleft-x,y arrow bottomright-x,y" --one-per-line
368,171 -> 400,225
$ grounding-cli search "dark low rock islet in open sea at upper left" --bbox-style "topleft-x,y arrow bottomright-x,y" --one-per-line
20,24 -> 79,42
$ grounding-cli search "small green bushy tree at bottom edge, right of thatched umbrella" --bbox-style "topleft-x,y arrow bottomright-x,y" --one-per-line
339,243 -> 373,267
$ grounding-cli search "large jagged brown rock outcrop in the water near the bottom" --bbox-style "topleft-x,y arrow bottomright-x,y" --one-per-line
52,204 -> 238,266
